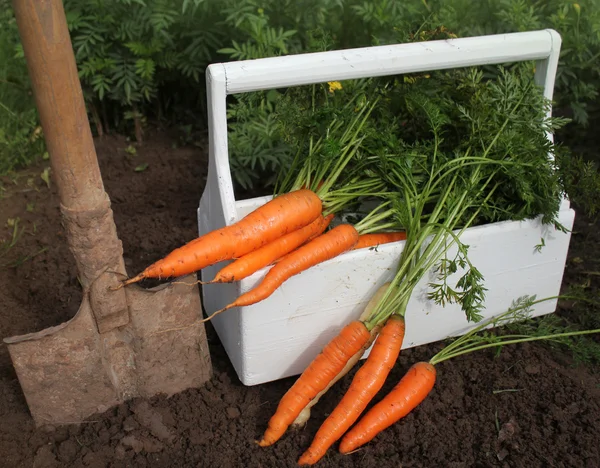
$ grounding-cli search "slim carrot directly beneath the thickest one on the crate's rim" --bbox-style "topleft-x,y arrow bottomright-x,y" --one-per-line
210,214 -> 333,283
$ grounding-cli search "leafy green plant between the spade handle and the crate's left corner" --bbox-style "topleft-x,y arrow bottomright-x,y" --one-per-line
65,0 -> 224,142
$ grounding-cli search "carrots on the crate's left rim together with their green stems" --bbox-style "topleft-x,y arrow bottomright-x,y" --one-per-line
123,92 -> 406,320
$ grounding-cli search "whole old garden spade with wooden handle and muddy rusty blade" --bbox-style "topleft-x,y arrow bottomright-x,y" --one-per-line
4,0 -> 212,426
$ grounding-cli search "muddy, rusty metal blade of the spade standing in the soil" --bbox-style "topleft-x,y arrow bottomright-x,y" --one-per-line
4,276 -> 211,426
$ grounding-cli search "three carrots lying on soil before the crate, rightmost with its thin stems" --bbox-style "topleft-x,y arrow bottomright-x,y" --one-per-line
258,294 -> 600,465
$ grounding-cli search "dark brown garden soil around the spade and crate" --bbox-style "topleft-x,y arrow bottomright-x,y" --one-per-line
0,133 -> 600,468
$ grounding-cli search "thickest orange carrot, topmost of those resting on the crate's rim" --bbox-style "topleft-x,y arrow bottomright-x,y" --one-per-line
123,189 -> 322,285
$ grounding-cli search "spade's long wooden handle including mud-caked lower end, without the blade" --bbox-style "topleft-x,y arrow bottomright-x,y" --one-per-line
13,0 -> 126,292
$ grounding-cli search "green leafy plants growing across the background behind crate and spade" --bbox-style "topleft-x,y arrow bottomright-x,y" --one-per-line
0,0 -> 600,194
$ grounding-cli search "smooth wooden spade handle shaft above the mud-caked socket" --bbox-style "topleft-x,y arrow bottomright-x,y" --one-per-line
13,0 -> 106,211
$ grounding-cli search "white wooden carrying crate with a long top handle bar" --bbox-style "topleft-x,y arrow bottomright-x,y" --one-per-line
198,30 -> 575,385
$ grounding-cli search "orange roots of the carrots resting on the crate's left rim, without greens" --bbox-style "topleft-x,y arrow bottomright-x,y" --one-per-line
123,185 -> 405,318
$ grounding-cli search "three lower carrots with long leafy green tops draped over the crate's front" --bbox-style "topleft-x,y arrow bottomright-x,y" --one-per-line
259,69 -> 580,465
